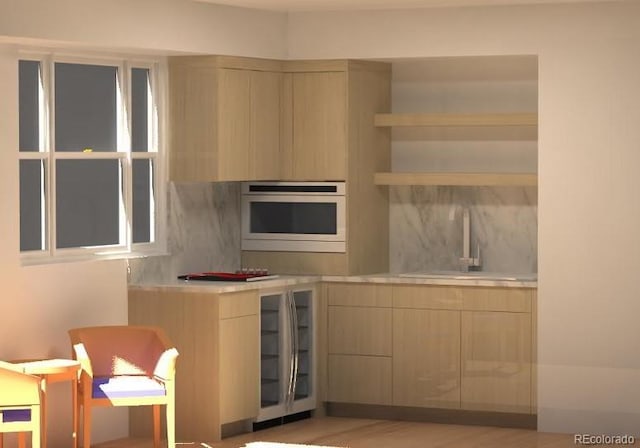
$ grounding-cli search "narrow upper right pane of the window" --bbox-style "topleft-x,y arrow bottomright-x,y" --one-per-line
131,68 -> 151,152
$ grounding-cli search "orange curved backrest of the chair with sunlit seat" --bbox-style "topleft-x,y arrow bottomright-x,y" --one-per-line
69,326 -> 170,377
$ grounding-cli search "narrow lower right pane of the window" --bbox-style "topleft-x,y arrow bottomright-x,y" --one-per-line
132,160 -> 155,243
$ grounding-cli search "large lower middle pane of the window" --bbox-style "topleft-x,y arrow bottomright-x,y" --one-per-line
56,160 -> 122,248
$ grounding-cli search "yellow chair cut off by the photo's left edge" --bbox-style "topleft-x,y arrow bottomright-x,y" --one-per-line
0,361 -> 42,448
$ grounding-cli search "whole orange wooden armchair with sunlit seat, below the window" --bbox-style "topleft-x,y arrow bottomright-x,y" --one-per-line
69,326 -> 178,448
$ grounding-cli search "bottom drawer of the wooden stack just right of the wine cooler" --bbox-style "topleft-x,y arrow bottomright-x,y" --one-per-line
327,355 -> 391,405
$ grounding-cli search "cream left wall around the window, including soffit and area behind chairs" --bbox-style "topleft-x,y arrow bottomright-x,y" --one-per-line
0,0 -> 286,446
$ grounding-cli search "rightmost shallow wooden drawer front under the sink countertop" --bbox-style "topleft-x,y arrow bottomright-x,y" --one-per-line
461,287 -> 534,313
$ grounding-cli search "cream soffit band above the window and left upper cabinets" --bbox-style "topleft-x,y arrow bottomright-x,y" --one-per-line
0,0 -> 286,58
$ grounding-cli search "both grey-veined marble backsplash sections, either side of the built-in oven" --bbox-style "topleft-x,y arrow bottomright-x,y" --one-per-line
130,182 -> 538,283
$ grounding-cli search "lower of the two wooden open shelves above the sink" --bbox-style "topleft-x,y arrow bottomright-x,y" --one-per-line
374,173 -> 538,187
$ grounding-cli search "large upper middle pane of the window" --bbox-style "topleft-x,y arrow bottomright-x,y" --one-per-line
55,63 -> 118,151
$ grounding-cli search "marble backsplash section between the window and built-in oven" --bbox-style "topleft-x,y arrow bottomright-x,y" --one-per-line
130,182 -> 241,283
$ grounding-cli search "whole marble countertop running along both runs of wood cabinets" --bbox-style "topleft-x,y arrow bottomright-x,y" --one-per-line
129,273 -> 538,294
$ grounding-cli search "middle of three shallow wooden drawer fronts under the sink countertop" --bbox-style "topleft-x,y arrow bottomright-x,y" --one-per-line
393,285 -> 462,310
